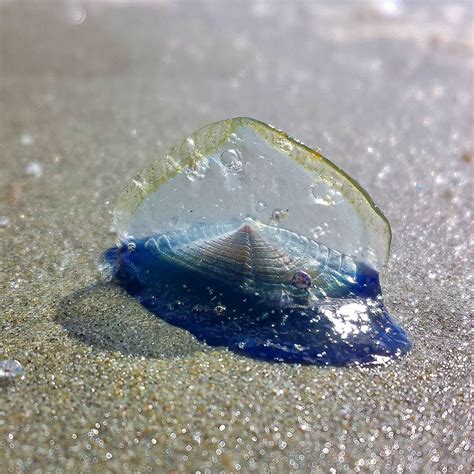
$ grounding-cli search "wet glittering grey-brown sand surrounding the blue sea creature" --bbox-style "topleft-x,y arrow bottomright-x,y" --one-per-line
0,0 -> 474,473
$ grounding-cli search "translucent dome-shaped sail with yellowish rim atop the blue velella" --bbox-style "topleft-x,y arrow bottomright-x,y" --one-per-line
114,118 -> 391,269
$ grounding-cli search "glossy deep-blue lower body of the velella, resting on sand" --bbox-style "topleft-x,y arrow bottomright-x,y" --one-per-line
105,239 -> 411,366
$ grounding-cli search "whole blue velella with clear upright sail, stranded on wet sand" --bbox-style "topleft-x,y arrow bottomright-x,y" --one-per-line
105,118 -> 410,366
